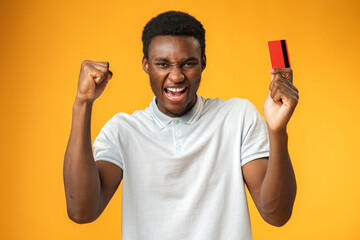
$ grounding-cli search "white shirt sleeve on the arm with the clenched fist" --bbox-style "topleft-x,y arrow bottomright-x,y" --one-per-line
93,116 -> 123,169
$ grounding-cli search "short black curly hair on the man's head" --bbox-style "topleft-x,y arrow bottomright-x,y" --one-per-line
142,11 -> 205,58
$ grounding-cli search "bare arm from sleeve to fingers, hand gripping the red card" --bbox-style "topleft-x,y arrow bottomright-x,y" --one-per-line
243,68 -> 299,226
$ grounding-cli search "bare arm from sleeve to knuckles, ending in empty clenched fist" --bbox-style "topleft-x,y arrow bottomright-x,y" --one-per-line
63,61 -> 122,223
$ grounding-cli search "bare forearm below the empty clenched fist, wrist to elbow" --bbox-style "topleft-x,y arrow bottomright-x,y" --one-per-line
64,99 -> 100,223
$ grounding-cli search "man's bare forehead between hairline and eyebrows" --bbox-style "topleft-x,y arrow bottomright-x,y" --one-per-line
148,35 -> 201,60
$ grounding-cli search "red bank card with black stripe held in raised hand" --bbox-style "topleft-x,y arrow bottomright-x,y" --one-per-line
268,40 -> 290,68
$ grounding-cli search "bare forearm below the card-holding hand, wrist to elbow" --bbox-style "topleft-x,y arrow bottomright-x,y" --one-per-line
260,130 -> 296,226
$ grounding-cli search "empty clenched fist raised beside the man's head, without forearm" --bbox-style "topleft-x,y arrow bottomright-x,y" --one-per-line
76,60 -> 112,102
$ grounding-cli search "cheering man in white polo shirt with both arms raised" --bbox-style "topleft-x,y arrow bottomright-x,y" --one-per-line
64,12 -> 298,240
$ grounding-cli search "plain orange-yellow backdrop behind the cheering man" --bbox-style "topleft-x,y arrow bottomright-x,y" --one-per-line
0,0 -> 360,240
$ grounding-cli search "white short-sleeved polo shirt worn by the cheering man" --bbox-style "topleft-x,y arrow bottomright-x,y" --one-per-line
94,96 -> 269,240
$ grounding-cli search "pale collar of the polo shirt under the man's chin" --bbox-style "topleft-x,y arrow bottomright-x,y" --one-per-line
150,95 -> 204,129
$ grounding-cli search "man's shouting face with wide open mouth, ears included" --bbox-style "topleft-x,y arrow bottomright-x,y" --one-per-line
142,35 -> 205,117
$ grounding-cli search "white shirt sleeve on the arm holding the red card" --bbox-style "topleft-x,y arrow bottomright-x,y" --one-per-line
241,101 -> 269,166
